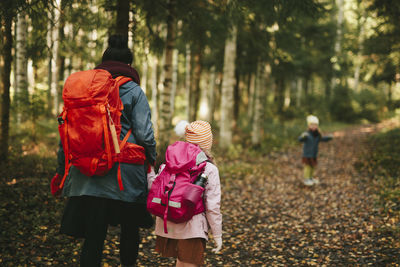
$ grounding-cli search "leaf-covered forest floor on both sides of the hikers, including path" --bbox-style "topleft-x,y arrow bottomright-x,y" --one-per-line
0,120 -> 400,266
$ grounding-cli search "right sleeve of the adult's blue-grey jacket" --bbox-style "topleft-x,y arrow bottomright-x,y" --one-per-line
131,87 -> 157,165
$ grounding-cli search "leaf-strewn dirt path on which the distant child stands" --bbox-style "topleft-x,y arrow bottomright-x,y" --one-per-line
135,122 -> 400,266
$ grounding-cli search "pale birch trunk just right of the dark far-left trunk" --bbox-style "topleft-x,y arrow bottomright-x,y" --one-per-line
14,12 -> 29,127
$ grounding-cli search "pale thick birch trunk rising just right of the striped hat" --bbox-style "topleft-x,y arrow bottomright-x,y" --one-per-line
220,26 -> 237,148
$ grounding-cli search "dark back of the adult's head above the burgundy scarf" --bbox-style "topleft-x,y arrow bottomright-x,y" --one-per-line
101,34 -> 133,64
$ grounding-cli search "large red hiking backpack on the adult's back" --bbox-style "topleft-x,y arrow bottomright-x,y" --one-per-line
58,69 -> 146,190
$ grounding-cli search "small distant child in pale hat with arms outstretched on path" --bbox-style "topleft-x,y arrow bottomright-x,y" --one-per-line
298,115 -> 333,186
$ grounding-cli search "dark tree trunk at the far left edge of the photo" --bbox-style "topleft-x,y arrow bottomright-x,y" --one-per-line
0,14 -> 13,162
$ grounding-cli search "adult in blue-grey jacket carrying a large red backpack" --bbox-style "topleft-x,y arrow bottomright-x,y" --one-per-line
51,35 -> 156,266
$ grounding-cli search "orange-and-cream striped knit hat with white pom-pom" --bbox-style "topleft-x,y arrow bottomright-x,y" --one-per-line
175,121 -> 213,151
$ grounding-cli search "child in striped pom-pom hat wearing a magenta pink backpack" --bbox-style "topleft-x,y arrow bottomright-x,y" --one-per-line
147,121 -> 222,266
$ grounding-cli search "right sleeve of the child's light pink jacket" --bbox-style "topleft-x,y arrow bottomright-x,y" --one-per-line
205,163 -> 222,237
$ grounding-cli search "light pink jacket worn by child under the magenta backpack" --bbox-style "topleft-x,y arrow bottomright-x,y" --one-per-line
147,162 -> 222,240
